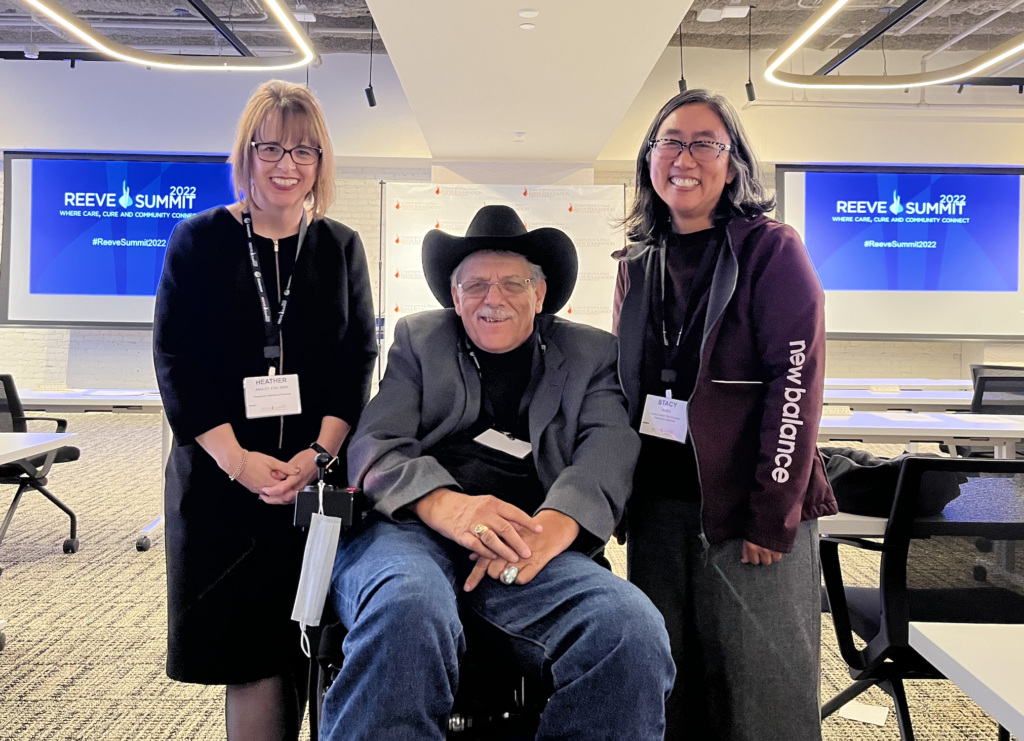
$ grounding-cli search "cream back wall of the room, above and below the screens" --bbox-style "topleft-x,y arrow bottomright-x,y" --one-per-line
0,48 -> 1024,386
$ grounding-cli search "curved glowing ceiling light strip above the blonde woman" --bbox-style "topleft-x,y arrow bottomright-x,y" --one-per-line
22,0 -> 315,72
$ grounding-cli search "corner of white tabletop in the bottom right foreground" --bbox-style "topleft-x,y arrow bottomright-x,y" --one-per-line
910,622 -> 1024,738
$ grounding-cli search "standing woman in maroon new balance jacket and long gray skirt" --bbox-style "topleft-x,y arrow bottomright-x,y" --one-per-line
614,90 -> 837,741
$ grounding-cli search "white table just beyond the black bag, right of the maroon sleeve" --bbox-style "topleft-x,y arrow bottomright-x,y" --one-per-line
817,411 -> 1024,459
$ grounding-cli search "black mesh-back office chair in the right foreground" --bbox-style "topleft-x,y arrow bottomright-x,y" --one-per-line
820,457 -> 1024,741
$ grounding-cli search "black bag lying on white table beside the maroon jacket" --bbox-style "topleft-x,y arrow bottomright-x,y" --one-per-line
820,447 -> 967,517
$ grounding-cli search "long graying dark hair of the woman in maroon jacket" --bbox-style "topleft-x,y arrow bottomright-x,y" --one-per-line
624,89 -> 775,244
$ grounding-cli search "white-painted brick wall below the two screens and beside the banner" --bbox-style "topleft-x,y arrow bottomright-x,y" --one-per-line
0,167 -> 1024,388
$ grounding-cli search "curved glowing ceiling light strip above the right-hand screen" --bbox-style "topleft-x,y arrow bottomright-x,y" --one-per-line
765,0 -> 1024,90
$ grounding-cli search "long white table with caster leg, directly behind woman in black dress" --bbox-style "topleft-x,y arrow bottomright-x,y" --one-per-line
18,389 -> 165,551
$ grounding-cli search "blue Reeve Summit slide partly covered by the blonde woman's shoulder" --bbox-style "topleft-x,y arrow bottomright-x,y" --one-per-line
29,160 -> 234,296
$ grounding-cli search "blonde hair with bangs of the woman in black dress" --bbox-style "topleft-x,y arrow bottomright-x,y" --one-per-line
228,80 -> 334,219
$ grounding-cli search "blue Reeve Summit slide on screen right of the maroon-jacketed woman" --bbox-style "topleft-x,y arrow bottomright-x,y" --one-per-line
804,172 -> 1021,291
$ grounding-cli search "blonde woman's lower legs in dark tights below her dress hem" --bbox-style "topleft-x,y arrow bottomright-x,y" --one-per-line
224,659 -> 309,741
